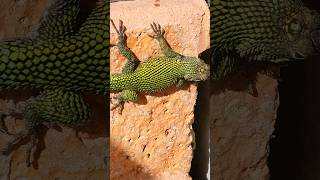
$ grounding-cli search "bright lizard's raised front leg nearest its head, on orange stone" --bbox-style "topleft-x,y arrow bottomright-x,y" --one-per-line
150,23 -> 184,58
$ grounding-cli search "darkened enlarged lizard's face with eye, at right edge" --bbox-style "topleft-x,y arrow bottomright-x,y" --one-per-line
284,4 -> 320,59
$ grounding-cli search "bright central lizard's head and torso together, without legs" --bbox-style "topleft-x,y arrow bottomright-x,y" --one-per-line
110,56 -> 209,93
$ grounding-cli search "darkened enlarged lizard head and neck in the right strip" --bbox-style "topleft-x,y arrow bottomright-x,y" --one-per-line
210,0 -> 320,80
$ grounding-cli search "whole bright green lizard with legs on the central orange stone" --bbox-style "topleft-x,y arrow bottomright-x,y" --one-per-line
110,21 -> 210,107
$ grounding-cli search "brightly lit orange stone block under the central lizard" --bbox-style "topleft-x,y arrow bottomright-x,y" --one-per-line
110,0 -> 209,180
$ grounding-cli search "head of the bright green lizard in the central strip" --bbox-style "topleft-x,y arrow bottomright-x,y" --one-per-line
181,57 -> 210,81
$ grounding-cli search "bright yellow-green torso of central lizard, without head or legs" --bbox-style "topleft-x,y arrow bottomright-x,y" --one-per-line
110,57 -> 188,93
